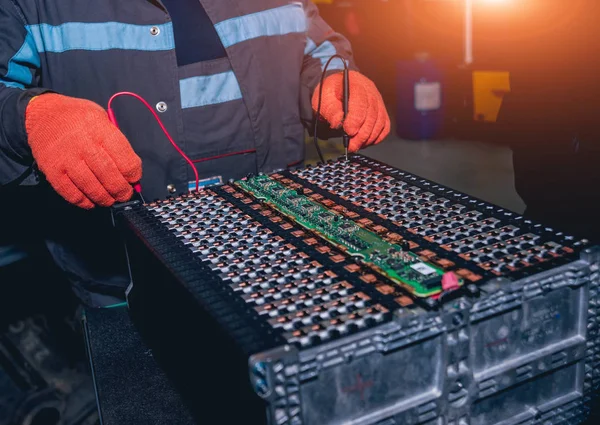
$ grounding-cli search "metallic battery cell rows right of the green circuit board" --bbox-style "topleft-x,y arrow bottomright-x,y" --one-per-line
297,163 -> 568,274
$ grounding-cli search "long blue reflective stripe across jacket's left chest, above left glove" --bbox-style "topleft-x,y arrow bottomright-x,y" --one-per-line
29,22 -> 175,53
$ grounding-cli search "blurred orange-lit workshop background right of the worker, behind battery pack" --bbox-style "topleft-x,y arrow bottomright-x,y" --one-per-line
316,0 -> 600,224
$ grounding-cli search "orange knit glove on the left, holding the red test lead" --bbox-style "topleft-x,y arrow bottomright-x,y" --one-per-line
25,93 -> 142,209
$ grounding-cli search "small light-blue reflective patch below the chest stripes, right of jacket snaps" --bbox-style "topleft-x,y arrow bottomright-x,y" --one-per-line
179,71 -> 242,109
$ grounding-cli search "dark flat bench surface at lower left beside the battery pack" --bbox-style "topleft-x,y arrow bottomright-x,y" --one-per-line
84,307 -> 196,425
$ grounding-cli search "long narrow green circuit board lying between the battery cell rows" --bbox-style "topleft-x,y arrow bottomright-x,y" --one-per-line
237,176 -> 463,297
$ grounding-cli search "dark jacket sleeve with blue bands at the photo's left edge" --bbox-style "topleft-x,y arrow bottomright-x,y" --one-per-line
0,0 -> 47,187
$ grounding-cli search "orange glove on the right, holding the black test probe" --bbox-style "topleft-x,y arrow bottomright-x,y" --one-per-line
312,71 -> 390,152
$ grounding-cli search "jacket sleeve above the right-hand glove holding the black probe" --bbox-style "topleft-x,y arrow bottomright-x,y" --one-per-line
300,0 -> 358,123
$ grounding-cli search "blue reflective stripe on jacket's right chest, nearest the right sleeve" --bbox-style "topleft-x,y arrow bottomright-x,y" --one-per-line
215,3 -> 307,48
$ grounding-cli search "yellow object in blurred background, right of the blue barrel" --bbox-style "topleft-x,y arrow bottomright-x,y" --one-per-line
473,71 -> 510,122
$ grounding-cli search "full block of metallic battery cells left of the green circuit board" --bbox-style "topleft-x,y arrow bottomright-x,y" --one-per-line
149,193 -> 380,345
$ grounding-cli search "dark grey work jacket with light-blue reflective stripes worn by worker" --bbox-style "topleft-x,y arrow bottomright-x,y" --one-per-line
0,0 -> 354,304
